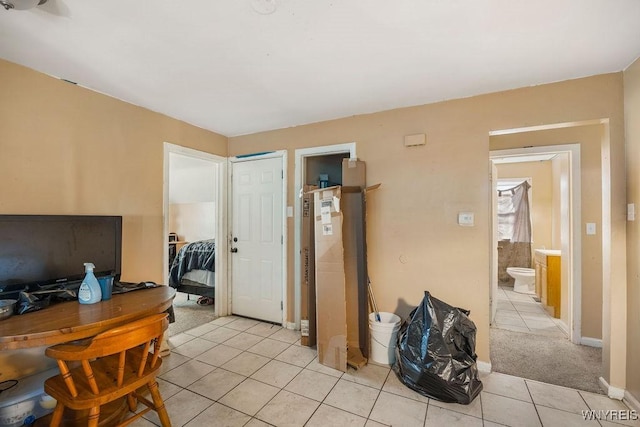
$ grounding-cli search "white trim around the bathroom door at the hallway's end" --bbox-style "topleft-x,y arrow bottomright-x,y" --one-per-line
489,144 -> 582,344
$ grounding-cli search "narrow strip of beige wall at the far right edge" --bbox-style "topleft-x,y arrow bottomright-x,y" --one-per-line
624,56 -> 640,400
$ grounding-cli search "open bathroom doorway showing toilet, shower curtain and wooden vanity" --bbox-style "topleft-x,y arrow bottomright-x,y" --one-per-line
491,152 -> 581,342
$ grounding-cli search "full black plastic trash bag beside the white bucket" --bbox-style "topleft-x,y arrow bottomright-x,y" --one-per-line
393,291 -> 482,405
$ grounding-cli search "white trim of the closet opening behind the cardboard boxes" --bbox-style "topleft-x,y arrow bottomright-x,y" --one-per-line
291,142 -> 357,329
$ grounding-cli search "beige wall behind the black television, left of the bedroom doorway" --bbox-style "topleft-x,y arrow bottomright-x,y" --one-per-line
0,60 -> 227,282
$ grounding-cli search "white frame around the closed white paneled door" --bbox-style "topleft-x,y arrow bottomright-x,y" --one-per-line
224,150 -> 289,326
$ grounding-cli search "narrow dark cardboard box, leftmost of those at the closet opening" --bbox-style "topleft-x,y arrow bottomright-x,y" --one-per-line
300,185 -> 318,347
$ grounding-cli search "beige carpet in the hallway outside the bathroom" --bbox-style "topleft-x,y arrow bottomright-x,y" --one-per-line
491,328 -> 602,393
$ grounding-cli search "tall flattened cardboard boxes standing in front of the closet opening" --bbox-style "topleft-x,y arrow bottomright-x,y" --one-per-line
301,159 -> 377,371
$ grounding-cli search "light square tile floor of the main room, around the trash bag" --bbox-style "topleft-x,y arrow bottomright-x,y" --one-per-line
133,316 -> 640,427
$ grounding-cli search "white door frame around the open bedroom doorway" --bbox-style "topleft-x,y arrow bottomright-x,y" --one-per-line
162,141 -> 229,316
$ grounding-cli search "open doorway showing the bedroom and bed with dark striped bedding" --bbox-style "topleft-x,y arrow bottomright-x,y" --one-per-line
164,143 -> 226,334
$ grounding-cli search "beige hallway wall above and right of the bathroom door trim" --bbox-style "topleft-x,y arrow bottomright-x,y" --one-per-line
490,124 -> 604,339
